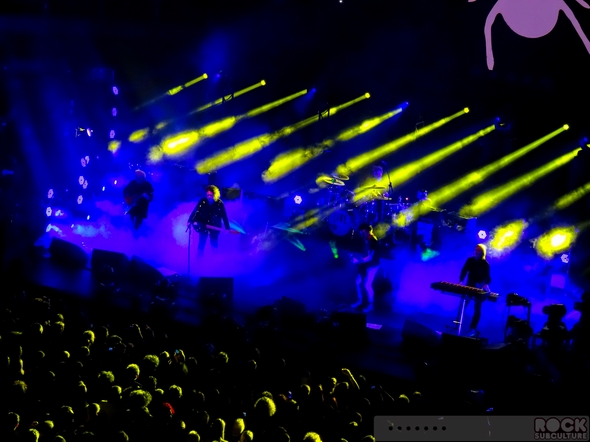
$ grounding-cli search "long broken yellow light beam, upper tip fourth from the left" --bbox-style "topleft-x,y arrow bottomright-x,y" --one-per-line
196,95 -> 367,174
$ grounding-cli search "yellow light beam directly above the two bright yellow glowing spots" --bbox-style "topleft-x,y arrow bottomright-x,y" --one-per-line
459,149 -> 580,217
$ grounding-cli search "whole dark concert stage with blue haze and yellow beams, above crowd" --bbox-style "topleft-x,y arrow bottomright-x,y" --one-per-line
0,0 -> 590,422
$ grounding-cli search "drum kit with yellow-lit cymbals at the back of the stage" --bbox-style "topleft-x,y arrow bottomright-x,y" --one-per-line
317,175 -> 408,236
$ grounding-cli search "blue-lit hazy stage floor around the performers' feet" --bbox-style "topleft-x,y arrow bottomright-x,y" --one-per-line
19,203 -> 582,378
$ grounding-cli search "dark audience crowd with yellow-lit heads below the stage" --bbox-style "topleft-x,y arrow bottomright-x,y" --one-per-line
0,284 -> 587,442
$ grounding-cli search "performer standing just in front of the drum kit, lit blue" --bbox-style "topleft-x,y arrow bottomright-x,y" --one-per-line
351,223 -> 379,313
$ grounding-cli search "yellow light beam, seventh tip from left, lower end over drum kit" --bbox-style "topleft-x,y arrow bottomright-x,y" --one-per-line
353,125 -> 495,201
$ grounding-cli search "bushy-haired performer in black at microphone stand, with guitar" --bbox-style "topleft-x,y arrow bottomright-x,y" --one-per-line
187,185 -> 230,256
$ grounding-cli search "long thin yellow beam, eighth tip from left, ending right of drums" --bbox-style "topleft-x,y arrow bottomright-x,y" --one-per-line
412,127 -> 566,219
